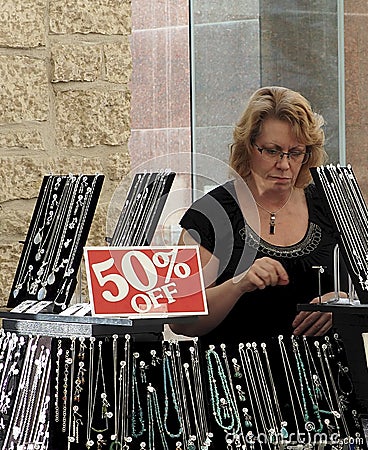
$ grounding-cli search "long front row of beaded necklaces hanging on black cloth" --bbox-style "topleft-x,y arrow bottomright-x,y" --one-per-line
0,331 -> 366,450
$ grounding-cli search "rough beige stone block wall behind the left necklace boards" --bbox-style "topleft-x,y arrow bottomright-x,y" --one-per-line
0,0 -> 132,306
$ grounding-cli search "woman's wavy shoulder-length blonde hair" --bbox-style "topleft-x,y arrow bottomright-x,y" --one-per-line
229,86 -> 328,188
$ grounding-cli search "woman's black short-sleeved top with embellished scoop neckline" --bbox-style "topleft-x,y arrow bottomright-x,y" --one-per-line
180,181 -> 337,344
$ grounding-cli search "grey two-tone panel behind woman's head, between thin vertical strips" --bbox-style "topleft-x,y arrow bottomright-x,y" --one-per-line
190,0 -> 344,195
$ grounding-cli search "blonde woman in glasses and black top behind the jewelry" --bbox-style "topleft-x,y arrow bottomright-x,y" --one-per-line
172,87 -> 342,343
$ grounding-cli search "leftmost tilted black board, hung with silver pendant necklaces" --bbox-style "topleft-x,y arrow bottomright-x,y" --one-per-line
7,174 -> 104,313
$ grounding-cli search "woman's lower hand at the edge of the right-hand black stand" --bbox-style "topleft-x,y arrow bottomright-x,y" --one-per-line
292,292 -> 347,336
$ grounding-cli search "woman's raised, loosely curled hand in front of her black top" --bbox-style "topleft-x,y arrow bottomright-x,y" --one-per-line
233,257 -> 289,294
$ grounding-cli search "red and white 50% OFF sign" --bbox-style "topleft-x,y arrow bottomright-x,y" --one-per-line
84,246 -> 208,318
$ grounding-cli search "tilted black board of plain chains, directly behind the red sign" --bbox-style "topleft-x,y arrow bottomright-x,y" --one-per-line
107,170 -> 176,247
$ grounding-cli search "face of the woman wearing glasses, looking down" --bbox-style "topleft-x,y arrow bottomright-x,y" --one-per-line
250,118 -> 306,190
